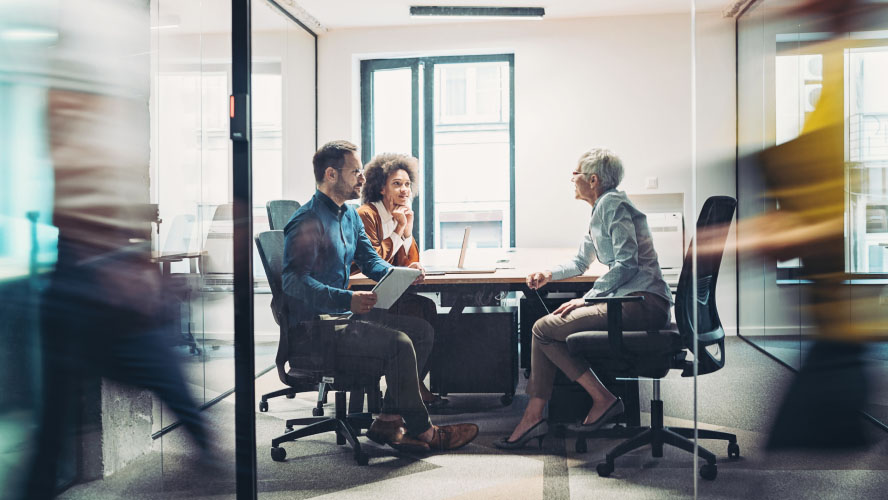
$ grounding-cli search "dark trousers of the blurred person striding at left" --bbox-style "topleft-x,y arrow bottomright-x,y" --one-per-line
26,241 -> 208,498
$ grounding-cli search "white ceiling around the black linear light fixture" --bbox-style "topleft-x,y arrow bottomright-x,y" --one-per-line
294,0 -> 733,30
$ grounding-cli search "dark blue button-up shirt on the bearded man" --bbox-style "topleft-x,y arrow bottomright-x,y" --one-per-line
283,191 -> 391,324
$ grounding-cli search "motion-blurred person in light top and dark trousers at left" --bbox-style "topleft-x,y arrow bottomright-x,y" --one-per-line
25,0 -> 207,499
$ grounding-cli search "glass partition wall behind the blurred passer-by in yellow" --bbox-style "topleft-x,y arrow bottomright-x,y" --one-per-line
737,1 -> 888,422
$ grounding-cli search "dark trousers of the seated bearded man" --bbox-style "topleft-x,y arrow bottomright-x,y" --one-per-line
336,310 -> 434,436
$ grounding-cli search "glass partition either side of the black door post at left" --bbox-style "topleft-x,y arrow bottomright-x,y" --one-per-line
150,0 -> 316,492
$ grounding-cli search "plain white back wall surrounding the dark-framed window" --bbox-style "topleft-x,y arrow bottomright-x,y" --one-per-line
306,13 -> 736,329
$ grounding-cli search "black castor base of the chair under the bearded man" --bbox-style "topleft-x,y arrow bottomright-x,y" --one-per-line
271,391 -> 373,465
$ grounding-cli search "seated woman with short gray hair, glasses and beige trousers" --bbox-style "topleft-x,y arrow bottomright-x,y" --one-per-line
494,148 -> 673,449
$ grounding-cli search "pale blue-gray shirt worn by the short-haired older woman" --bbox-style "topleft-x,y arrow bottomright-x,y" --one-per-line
552,189 -> 674,303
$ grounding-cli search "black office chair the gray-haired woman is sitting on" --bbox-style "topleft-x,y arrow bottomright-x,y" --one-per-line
567,196 -> 740,480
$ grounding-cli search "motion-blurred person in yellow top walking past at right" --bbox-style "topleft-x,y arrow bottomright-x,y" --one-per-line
738,0 -> 886,449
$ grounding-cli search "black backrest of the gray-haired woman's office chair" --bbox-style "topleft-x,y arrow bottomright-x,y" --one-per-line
675,196 -> 737,376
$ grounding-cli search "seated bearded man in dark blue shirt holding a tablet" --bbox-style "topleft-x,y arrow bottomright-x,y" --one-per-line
283,141 -> 478,450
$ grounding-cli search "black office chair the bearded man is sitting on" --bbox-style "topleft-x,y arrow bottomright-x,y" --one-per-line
256,231 -> 379,465
